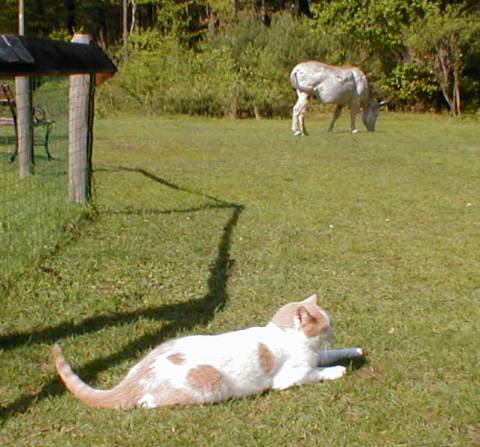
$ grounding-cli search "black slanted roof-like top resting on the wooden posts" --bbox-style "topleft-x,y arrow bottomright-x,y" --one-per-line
0,34 -> 117,76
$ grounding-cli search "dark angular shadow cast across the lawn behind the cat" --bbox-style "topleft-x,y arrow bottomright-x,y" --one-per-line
0,168 -> 244,424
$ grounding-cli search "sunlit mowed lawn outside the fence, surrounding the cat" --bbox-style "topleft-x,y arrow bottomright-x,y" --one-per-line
0,114 -> 480,446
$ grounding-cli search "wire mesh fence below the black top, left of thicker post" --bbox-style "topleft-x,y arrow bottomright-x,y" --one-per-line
0,77 -> 89,287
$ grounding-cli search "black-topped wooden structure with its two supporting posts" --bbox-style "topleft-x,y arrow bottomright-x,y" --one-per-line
0,34 -> 117,202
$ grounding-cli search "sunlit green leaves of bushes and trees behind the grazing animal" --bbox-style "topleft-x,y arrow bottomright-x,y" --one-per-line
94,0 -> 480,117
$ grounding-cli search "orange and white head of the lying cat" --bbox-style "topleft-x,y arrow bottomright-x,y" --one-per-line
271,295 -> 333,346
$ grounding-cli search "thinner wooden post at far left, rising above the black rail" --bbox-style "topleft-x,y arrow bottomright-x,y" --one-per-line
15,0 -> 33,178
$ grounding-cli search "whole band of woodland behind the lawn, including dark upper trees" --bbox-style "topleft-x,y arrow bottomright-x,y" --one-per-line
0,0 -> 480,117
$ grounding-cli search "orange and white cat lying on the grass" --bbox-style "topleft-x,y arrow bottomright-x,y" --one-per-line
53,295 -> 346,409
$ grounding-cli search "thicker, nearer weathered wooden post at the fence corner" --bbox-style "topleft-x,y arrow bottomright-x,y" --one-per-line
68,34 -> 95,202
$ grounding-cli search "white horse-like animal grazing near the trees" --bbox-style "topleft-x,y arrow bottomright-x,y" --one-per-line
290,61 -> 386,135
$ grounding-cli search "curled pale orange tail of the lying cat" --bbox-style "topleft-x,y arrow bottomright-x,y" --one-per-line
52,344 -> 135,409
